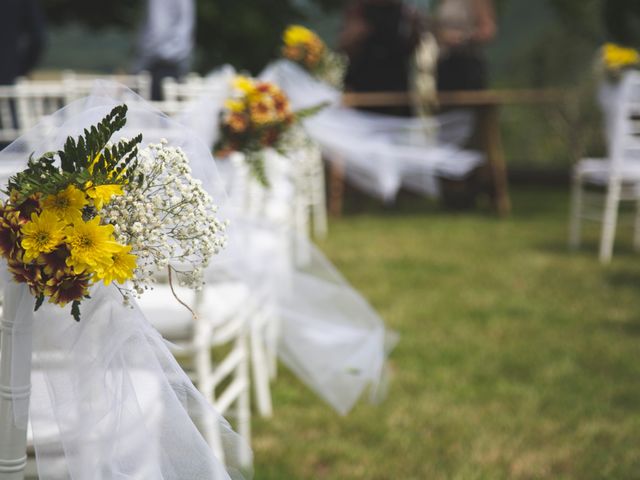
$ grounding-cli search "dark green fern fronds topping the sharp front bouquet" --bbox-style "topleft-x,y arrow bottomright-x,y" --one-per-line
7,105 -> 142,203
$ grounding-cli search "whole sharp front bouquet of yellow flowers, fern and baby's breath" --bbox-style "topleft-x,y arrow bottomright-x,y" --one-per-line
0,105 -> 224,320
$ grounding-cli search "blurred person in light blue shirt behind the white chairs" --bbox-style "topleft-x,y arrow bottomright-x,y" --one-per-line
134,0 -> 196,100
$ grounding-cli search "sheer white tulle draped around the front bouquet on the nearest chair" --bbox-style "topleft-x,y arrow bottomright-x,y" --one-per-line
0,84 -> 251,480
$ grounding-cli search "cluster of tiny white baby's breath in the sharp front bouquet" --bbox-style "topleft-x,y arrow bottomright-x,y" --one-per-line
102,141 -> 226,296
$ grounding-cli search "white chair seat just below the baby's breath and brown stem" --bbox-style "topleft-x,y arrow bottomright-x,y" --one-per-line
138,282 -> 249,340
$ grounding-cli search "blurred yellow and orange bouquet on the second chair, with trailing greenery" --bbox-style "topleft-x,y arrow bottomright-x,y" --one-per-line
214,76 -> 324,187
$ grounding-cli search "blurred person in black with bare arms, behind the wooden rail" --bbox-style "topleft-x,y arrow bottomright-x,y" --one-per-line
339,0 -> 423,115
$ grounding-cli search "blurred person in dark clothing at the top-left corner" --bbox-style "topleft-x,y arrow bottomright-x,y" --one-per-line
0,0 -> 45,85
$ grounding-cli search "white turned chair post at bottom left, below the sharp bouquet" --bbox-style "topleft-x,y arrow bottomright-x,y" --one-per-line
0,306 -> 31,480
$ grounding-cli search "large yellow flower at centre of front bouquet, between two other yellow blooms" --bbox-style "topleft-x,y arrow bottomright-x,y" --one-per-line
65,217 -> 121,274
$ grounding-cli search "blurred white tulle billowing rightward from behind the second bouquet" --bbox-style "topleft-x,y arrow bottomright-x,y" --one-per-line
261,60 -> 484,202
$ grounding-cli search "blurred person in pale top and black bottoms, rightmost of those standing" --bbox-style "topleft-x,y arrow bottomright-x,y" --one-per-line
433,0 -> 497,91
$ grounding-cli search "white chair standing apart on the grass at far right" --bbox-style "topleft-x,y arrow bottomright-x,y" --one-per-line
569,72 -> 640,264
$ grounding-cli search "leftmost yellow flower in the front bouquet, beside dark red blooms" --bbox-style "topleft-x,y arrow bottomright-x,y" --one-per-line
20,210 -> 66,263
